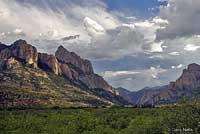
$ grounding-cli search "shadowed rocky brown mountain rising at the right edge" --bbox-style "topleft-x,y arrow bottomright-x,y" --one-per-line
148,63 -> 200,104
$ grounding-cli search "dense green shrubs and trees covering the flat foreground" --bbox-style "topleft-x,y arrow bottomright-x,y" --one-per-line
0,106 -> 200,134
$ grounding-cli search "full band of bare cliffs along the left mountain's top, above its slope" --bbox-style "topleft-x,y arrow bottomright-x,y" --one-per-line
0,40 -> 118,94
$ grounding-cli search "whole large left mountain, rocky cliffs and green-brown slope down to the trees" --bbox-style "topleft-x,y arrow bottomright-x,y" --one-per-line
0,40 -> 128,107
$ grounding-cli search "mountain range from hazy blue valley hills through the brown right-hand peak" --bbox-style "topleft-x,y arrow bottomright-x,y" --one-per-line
118,63 -> 200,105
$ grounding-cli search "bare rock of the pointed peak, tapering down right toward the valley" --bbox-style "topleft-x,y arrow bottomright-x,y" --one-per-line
55,46 -> 119,95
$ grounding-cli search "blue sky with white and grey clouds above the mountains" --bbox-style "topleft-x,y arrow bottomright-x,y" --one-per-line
0,0 -> 200,91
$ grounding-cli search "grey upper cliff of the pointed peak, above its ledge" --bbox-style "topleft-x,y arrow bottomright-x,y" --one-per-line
55,46 -> 94,74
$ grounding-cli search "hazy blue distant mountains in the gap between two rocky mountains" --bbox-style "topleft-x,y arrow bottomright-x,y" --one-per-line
117,86 -> 165,105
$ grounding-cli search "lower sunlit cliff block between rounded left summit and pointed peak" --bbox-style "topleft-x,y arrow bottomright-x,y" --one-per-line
38,53 -> 60,75
